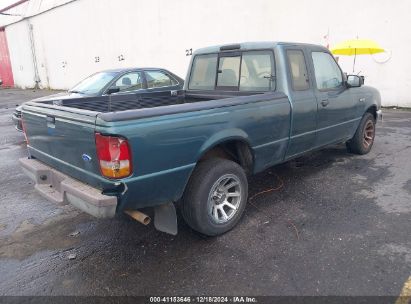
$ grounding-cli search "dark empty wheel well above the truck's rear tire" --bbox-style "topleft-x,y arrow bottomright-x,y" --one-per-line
199,140 -> 254,174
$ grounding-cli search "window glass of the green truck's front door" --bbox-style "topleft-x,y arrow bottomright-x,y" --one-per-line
312,52 -> 342,90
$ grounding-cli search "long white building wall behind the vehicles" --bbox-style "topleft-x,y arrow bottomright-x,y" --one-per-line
6,0 -> 411,107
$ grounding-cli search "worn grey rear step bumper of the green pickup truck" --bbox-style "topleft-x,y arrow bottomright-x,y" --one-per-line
20,158 -> 117,218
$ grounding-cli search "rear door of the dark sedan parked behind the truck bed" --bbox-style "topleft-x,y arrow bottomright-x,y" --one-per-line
140,70 -> 183,108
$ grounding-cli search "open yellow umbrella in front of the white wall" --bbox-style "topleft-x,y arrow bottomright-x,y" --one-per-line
331,39 -> 385,73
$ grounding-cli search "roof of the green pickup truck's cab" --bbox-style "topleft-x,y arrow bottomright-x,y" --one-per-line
194,41 -> 327,54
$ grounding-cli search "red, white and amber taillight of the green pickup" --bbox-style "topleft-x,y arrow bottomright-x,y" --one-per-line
96,133 -> 132,178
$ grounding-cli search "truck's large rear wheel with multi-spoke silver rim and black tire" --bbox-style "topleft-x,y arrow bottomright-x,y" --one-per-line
181,158 -> 248,236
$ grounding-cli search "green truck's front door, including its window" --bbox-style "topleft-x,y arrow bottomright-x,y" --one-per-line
311,50 -> 358,147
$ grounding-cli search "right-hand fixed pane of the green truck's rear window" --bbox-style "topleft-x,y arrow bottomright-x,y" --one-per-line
240,51 -> 274,92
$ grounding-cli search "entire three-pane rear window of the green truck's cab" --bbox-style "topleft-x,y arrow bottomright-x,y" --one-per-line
188,51 -> 275,92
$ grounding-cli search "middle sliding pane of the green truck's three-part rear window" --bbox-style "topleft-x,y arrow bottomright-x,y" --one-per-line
217,56 -> 241,90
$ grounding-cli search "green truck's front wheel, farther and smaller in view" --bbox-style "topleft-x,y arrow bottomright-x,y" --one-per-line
347,112 -> 375,155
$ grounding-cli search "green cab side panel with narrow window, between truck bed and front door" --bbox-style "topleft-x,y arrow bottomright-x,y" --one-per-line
286,48 -> 317,158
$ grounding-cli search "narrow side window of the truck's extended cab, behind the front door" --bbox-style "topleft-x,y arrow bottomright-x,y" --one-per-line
287,50 -> 310,91
